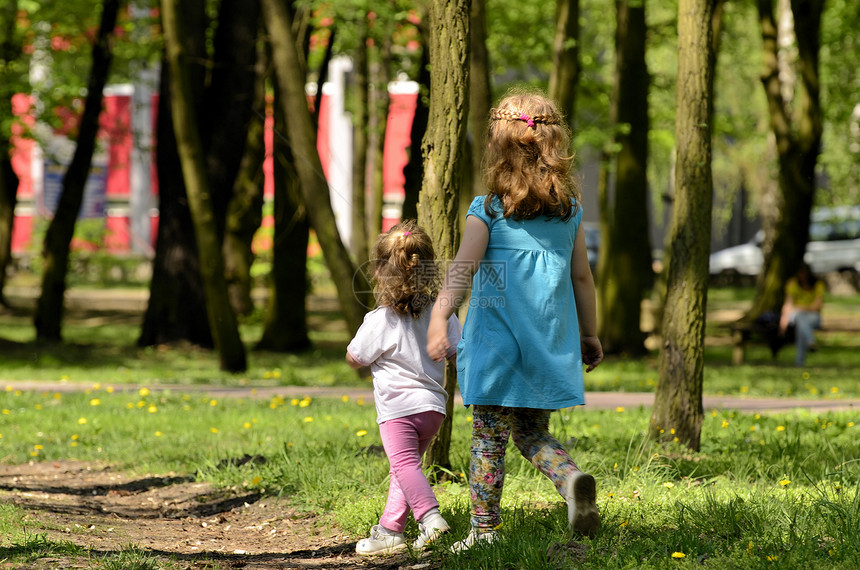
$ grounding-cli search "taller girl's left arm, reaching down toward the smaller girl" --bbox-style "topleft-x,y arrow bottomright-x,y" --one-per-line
427,216 -> 490,360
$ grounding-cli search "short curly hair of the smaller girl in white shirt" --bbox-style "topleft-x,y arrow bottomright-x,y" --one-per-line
370,220 -> 440,317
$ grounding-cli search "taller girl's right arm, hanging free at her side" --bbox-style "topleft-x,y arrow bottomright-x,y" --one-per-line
570,224 -> 603,372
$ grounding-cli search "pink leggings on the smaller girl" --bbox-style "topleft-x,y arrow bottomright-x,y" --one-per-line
379,412 -> 445,532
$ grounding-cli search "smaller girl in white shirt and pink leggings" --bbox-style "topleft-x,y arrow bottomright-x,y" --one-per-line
346,220 -> 461,555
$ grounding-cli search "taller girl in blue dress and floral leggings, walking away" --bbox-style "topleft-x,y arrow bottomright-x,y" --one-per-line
427,89 -> 603,548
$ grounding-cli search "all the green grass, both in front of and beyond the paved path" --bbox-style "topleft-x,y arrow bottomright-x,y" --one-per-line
0,282 -> 860,569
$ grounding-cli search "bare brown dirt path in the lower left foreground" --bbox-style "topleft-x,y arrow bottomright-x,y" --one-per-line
0,461 -> 414,569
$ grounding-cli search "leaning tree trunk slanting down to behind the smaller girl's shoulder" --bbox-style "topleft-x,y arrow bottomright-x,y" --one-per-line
263,0 -> 370,334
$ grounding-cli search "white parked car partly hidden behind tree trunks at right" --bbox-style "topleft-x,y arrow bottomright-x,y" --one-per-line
709,206 -> 860,276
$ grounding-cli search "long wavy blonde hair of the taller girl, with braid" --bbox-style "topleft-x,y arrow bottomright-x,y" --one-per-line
484,90 -> 580,219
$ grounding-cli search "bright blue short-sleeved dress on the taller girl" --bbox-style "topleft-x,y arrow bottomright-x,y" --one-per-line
457,196 -> 585,410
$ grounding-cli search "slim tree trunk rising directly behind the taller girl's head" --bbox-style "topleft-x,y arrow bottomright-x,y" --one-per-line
549,0 -> 580,131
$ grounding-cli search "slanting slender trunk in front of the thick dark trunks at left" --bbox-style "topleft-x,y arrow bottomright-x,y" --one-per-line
162,0 -> 247,372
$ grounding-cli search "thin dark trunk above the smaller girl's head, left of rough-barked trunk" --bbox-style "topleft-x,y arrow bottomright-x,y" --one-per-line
402,18 -> 431,220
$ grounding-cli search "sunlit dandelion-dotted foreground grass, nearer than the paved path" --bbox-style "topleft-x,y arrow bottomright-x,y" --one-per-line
0,388 -> 860,568
